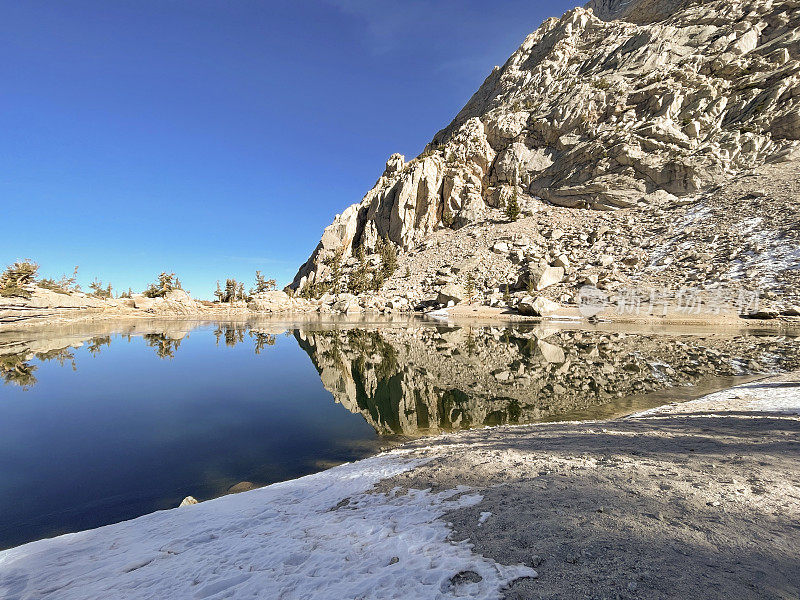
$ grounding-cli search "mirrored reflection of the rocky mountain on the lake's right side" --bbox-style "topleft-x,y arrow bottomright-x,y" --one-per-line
295,327 -> 800,436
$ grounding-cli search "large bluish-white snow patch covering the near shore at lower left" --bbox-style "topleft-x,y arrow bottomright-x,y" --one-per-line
0,450 -> 536,600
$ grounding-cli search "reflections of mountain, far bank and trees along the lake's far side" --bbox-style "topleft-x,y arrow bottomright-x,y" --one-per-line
0,321 -> 800,436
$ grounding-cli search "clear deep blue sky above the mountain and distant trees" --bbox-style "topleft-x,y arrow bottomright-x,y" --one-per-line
0,0 -> 576,297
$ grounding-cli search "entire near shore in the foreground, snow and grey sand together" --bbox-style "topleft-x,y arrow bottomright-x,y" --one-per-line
0,373 -> 800,599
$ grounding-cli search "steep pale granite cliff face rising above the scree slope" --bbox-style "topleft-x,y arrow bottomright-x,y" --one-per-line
291,0 -> 800,289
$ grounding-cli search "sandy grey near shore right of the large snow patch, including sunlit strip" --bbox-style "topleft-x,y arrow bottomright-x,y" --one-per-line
379,373 -> 800,599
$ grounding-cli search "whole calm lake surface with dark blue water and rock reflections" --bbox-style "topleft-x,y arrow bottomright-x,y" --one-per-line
0,320 -> 800,548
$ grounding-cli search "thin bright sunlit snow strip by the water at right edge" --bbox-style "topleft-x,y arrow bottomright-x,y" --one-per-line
631,379 -> 800,417
